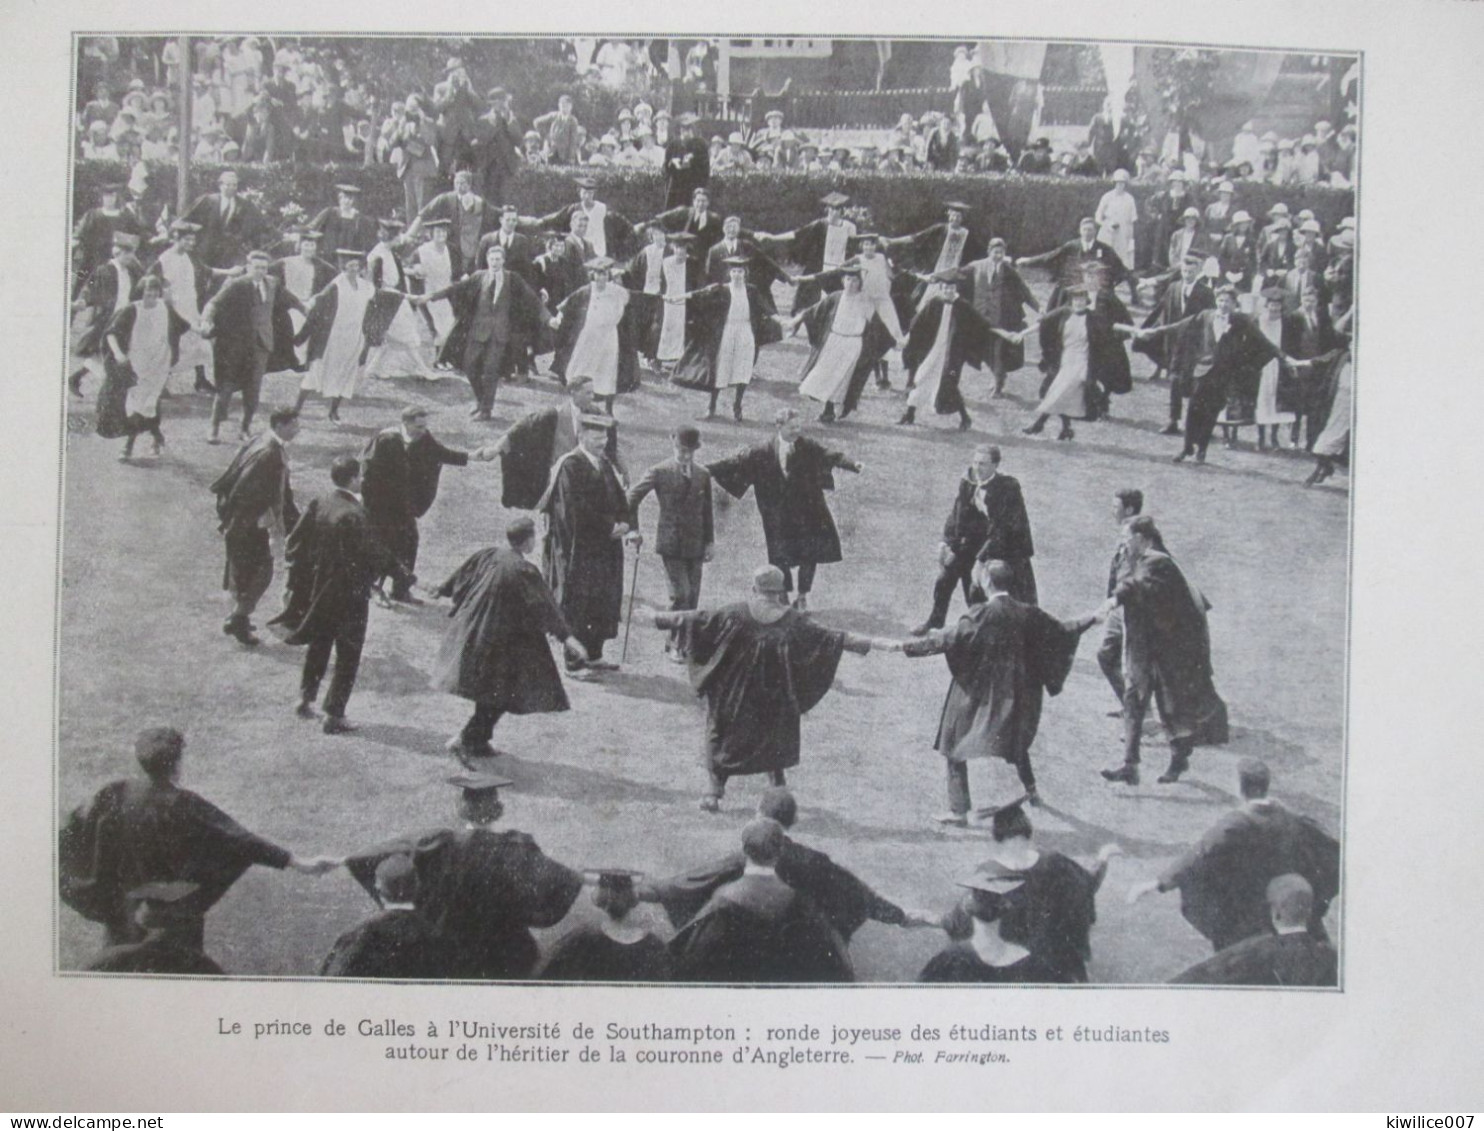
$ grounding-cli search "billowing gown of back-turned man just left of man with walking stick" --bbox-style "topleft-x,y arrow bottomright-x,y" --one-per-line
433,548 -> 570,715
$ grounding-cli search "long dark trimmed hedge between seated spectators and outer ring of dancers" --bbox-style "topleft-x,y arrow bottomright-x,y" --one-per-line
73,162 -> 1355,255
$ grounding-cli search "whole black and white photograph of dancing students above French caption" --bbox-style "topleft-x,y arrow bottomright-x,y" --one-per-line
55,27 -> 1373,991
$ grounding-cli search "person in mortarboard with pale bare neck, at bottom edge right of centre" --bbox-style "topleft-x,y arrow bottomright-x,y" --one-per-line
917,867 -> 1073,986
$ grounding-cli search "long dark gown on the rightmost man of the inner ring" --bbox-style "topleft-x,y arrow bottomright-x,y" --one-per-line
1113,551 -> 1227,745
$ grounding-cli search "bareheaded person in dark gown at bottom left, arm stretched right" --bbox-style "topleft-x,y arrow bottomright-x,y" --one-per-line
56,727 -> 337,950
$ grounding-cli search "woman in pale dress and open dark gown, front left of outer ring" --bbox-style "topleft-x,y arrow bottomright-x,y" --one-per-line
96,276 -> 190,460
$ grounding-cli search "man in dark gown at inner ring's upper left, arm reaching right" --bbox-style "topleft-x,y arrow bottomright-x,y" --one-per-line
361,405 -> 494,604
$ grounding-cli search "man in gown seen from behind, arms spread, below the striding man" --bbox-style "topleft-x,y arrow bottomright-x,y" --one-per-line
890,561 -> 1097,828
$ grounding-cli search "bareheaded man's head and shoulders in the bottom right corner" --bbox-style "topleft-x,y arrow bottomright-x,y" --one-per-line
1169,873 -> 1340,986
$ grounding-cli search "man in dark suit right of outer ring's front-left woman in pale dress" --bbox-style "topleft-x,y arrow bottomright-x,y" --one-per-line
200,251 -> 307,444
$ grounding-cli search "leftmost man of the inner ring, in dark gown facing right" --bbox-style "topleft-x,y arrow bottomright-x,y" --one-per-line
211,408 -> 298,646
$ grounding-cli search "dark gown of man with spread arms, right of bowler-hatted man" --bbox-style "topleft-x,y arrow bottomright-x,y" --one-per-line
708,436 -> 859,566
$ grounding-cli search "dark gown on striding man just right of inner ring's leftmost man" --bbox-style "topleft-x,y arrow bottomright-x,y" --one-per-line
270,490 -> 388,644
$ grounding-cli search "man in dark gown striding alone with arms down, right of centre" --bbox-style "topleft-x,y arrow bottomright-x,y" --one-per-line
913,444 -> 1036,637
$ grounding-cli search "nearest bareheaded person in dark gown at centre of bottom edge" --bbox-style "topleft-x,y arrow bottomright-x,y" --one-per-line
669,819 -> 855,983
